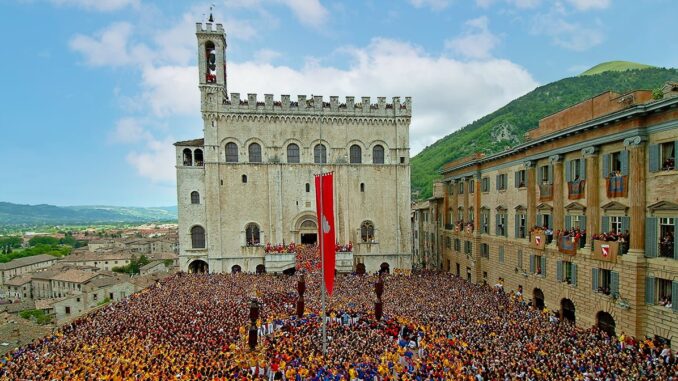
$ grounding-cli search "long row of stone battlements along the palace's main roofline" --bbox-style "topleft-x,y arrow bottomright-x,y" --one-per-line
224,93 -> 412,117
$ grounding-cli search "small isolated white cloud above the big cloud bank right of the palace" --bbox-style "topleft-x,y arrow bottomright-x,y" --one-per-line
445,16 -> 499,59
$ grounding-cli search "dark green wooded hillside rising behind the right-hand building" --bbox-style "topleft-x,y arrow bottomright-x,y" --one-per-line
411,68 -> 678,199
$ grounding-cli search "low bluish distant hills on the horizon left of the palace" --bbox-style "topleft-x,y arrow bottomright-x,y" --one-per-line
0,202 -> 177,225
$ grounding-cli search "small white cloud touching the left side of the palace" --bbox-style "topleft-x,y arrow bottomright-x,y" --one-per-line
125,137 -> 176,182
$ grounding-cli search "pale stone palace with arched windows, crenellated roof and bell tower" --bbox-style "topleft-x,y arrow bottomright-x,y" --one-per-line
175,24 -> 411,272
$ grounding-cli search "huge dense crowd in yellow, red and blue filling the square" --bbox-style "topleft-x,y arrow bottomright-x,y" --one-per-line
0,247 -> 678,381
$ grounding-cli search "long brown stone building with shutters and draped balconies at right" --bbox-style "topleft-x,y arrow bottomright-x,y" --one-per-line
430,86 -> 678,349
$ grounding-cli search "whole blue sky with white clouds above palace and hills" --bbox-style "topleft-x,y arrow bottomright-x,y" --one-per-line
0,0 -> 678,206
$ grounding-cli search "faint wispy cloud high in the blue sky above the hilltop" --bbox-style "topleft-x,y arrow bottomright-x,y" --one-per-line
532,14 -> 605,52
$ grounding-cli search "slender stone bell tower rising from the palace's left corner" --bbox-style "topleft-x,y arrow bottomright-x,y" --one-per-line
195,14 -> 228,111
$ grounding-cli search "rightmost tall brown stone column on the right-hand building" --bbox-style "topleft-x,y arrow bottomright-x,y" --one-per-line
624,136 -> 645,256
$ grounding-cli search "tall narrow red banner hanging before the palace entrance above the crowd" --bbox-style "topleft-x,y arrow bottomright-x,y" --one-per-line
315,172 -> 336,296
